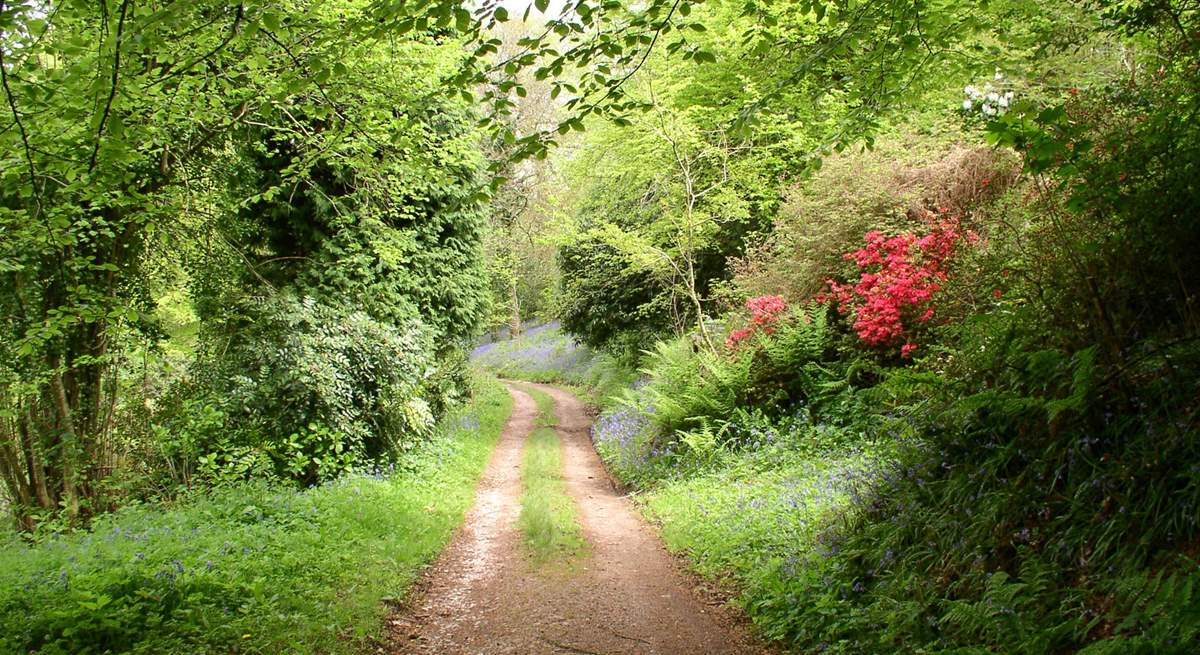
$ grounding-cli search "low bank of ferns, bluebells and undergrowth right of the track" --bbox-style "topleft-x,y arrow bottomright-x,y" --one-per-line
593,313 -> 1200,655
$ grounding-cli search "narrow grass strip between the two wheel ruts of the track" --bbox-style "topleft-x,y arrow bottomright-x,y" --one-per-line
518,387 -> 587,566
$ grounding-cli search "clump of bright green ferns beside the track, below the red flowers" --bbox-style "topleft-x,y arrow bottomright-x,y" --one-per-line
592,302 -> 874,487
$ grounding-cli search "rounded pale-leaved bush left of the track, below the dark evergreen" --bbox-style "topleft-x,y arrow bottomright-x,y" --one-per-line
175,296 -> 439,483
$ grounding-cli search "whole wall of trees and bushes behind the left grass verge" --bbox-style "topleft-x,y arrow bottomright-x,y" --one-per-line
0,2 -> 501,527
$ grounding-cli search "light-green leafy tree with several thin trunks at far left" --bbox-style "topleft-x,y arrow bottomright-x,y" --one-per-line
0,0 -> 391,516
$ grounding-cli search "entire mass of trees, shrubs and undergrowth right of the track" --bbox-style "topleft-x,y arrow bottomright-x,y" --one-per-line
537,2 -> 1200,654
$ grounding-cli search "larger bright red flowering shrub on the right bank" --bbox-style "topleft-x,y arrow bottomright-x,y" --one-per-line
817,210 -> 978,357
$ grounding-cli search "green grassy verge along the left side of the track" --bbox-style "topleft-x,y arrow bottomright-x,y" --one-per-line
0,371 -> 511,654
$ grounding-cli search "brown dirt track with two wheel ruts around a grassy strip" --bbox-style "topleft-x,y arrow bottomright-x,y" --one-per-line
390,385 -> 773,655
